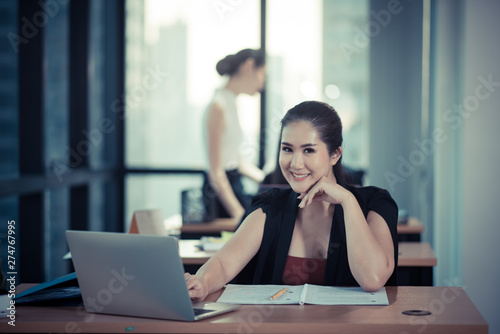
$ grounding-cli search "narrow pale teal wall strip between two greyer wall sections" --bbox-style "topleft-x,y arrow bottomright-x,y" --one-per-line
430,0 -> 465,294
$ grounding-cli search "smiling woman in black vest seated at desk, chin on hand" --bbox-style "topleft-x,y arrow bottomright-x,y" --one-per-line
186,101 -> 398,300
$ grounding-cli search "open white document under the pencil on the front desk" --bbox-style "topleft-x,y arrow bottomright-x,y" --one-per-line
217,284 -> 389,305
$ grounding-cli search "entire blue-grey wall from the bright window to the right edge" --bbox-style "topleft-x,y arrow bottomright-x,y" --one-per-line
369,0 -> 500,333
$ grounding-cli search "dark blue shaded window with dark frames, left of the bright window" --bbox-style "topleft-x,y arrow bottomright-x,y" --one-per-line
0,0 -> 124,283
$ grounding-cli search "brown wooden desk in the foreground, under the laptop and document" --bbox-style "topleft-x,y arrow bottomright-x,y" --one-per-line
5,284 -> 488,334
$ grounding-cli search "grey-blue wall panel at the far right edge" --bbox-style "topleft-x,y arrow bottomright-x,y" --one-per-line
461,0 -> 500,333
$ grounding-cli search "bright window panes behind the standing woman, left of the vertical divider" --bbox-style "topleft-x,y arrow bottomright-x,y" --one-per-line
125,0 -> 260,224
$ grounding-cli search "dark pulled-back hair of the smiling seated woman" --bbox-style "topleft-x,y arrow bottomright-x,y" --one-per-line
280,101 -> 346,183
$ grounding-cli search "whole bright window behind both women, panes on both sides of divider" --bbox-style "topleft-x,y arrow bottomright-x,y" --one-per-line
124,0 -> 369,224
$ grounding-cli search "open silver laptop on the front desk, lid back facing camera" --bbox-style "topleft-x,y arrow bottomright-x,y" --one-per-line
66,231 -> 240,321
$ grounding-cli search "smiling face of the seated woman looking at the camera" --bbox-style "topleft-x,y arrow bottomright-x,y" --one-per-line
279,121 -> 339,193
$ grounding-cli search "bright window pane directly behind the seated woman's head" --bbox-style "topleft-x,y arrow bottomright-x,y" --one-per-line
265,0 -> 369,169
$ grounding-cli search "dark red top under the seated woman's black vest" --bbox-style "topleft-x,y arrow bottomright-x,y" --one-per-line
281,255 -> 326,285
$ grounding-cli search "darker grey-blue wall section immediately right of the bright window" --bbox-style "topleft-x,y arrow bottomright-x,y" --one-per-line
368,0 -> 432,230
